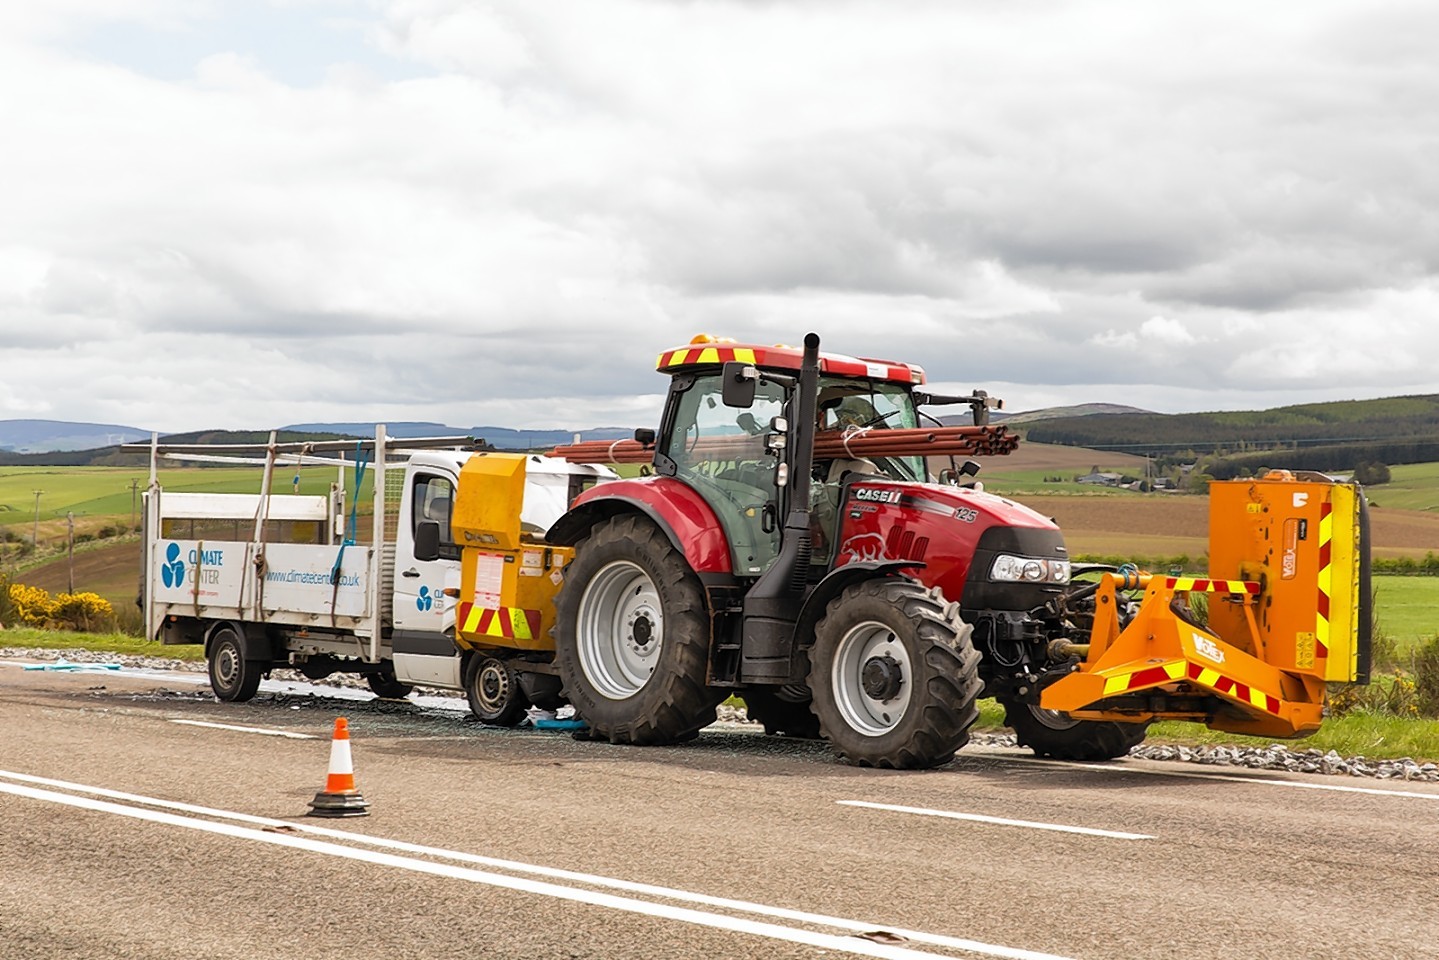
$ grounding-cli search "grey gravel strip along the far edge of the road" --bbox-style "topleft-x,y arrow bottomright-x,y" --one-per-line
0,646 -> 1439,783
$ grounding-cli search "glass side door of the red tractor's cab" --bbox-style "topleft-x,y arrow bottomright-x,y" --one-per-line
656,373 -> 784,577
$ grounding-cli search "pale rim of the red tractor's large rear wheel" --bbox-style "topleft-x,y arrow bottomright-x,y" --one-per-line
576,560 -> 665,699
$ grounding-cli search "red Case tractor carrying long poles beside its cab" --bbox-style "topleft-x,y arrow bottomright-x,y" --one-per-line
547,334 -> 1145,769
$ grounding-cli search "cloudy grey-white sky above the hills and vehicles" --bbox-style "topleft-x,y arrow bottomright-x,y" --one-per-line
0,0 -> 1439,430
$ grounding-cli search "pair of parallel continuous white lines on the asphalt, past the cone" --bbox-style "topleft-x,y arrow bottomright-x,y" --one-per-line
0,770 -> 1068,960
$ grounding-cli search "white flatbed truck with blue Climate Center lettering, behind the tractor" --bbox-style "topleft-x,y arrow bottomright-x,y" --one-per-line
127,426 -> 614,704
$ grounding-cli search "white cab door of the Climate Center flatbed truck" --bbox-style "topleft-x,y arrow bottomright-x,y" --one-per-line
391,469 -> 460,689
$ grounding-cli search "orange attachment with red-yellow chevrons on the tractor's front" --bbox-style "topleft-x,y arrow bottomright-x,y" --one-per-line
1040,471 -> 1371,738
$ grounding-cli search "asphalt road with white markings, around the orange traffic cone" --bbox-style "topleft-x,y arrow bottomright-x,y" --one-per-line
0,665 -> 1439,960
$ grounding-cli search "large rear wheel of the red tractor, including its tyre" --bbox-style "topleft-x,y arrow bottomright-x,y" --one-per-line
555,517 -> 724,744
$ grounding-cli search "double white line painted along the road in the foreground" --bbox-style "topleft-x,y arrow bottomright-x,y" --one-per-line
0,770 -> 1069,960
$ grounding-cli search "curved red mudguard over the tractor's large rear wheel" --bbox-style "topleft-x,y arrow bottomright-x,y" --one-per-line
545,476 -> 732,574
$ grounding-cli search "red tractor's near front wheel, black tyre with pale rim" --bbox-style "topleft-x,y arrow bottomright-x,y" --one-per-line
809,579 -> 981,770
